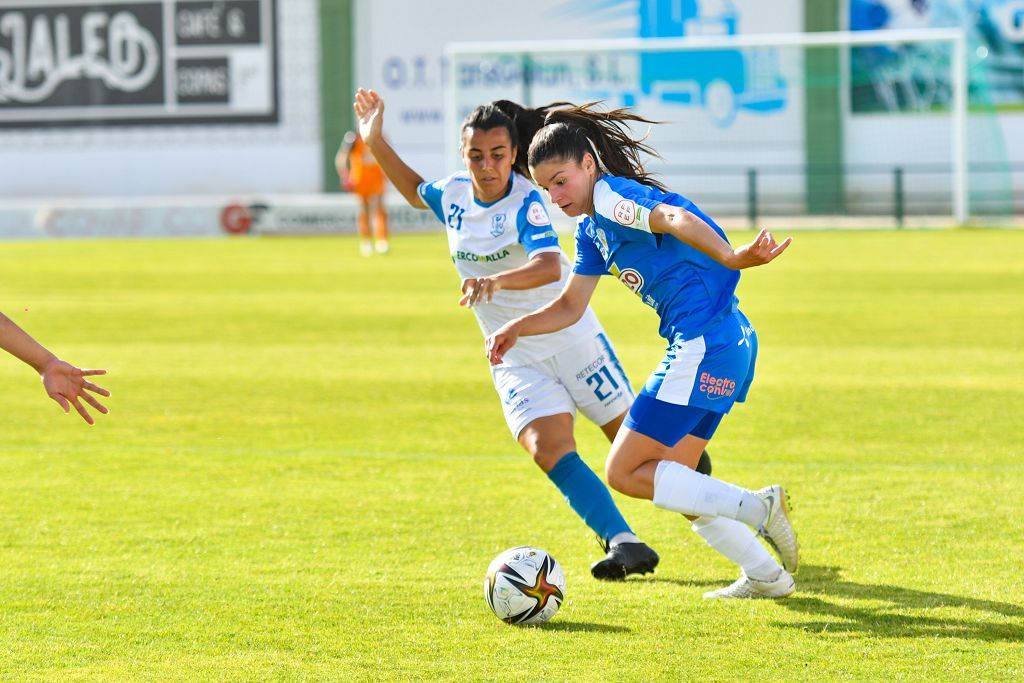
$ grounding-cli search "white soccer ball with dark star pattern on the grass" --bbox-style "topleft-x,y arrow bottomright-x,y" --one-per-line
483,546 -> 565,625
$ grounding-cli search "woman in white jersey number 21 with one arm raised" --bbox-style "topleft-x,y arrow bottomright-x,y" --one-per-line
353,88 -> 704,580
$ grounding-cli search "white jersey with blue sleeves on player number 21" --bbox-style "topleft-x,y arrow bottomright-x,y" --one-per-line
419,171 -> 601,366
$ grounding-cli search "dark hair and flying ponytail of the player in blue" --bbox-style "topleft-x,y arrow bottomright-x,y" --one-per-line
526,102 -> 668,191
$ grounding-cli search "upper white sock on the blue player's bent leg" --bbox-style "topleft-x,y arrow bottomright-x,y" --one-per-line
654,460 -> 768,527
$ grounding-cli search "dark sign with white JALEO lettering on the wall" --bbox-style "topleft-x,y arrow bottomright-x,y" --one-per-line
0,0 -> 278,127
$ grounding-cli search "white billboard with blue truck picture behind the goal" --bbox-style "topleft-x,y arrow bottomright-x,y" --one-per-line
355,0 -> 803,185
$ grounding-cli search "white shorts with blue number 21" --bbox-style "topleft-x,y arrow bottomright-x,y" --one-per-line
490,332 -> 635,439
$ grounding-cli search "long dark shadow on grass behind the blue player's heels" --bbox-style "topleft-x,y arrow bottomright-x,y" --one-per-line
778,566 -> 1024,642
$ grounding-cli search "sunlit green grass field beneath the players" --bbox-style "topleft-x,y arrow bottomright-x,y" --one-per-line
0,230 -> 1024,681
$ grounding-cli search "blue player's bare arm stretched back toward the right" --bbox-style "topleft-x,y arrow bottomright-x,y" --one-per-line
650,204 -> 793,270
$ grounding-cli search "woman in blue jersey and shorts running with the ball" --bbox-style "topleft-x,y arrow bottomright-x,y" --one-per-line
486,104 -> 799,598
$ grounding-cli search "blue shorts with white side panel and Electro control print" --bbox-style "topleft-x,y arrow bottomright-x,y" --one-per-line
625,310 -> 758,446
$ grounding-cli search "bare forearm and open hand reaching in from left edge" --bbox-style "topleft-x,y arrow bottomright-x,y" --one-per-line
0,313 -> 111,425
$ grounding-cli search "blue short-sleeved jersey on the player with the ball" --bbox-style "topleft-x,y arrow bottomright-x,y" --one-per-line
572,175 -> 739,341
